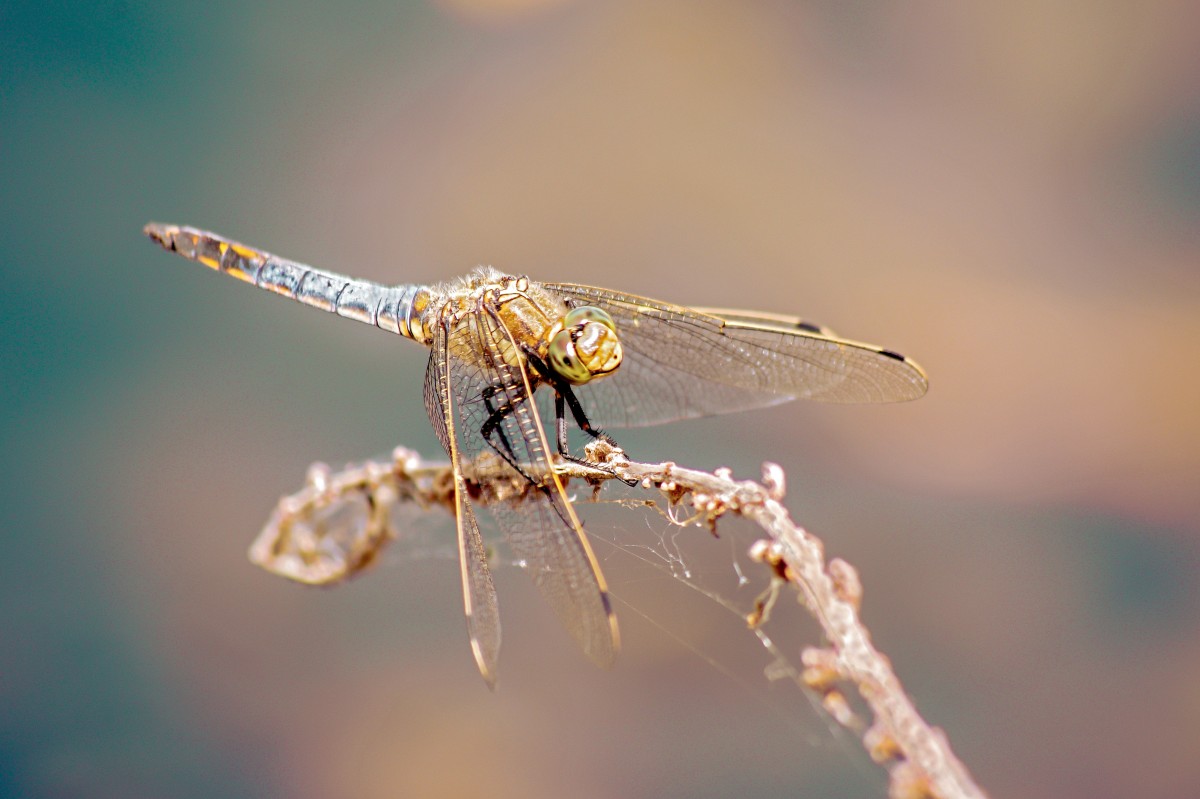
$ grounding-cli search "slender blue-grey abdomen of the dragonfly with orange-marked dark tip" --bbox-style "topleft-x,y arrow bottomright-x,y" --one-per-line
143,222 -> 428,343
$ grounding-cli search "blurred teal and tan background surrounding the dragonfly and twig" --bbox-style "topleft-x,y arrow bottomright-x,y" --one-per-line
0,0 -> 1200,798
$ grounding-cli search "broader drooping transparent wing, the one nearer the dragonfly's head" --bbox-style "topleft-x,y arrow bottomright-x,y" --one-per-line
448,304 -> 618,667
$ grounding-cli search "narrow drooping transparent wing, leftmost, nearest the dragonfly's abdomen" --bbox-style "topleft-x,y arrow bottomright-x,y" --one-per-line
425,330 -> 500,687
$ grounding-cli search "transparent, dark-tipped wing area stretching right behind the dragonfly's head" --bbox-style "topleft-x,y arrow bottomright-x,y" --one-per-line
545,283 -> 928,427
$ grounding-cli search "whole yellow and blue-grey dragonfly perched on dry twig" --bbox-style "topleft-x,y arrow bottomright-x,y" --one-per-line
144,222 -> 928,686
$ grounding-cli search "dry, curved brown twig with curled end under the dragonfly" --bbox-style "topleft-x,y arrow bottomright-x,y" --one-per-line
250,441 -> 985,799
